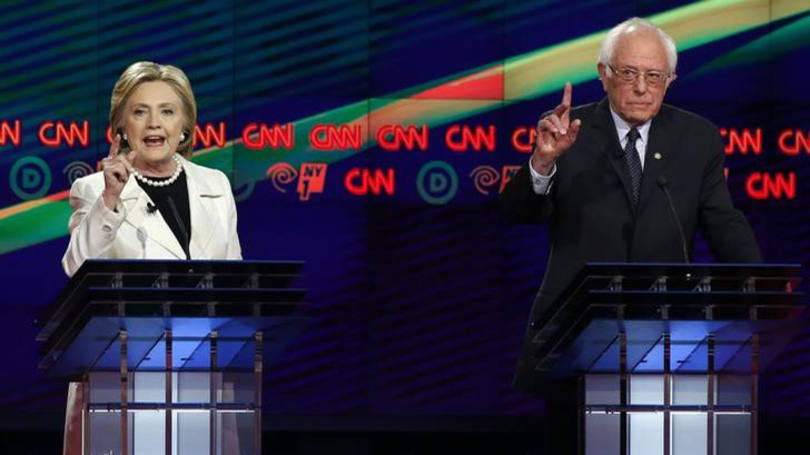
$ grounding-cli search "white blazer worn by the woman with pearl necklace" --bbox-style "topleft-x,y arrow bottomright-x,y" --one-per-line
62,158 -> 242,276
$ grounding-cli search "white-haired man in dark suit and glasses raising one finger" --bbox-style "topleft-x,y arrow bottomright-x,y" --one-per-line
501,18 -> 761,434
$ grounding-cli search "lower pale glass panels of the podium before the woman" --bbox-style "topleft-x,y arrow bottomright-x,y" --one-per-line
87,371 -> 260,455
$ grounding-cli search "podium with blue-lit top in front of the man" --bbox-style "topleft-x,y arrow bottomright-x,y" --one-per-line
532,263 -> 803,455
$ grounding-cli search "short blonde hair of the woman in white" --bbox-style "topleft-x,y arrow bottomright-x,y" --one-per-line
110,62 -> 197,157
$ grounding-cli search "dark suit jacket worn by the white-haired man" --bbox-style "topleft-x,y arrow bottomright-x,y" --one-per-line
501,99 -> 761,391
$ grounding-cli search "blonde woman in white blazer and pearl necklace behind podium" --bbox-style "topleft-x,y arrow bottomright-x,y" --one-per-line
62,62 -> 242,276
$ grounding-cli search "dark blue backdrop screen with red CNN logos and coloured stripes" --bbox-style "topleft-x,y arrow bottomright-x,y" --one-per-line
0,0 -> 810,427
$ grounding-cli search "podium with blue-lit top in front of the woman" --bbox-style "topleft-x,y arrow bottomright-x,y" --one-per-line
37,260 -> 305,455
